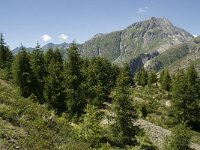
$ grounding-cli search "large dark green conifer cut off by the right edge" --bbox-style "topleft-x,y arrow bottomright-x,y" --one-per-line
172,66 -> 200,129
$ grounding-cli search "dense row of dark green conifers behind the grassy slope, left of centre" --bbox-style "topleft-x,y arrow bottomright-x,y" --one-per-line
11,44 -> 122,117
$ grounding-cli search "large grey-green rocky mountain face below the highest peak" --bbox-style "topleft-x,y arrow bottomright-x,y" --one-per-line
79,17 -> 193,64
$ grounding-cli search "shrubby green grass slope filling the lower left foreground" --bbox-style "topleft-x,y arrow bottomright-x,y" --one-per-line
0,76 -> 89,150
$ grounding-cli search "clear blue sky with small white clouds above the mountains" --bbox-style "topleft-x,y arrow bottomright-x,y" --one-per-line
0,0 -> 200,49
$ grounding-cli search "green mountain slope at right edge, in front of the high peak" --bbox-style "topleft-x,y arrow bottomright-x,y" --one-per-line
145,37 -> 200,73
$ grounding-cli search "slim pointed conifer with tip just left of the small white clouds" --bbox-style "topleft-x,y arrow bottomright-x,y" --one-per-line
31,43 -> 46,103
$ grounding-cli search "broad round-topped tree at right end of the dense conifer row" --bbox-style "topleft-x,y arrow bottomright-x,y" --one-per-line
85,57 -> 113,105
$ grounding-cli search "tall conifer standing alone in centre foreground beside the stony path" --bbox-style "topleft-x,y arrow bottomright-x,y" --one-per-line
112,67 -> 139,145
